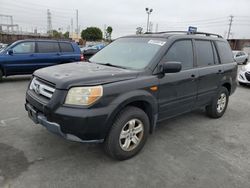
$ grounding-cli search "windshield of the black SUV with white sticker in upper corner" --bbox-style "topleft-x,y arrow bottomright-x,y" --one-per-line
90,38 -> 165,69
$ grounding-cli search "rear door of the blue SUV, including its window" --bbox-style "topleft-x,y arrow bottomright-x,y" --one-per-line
34,41 -> 61,70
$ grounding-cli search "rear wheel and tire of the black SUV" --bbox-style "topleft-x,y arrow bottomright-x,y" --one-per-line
206,87 -> 229,118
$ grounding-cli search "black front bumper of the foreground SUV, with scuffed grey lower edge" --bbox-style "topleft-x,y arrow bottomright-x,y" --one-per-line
25,90 -> 115,142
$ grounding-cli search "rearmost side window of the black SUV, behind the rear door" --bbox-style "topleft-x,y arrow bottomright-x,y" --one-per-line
216,41 -> 233,63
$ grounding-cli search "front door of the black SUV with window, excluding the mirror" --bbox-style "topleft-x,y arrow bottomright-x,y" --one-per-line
158,39 -> 198,120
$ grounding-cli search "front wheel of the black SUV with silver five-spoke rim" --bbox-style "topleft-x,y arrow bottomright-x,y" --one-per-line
104,106 -> 150,160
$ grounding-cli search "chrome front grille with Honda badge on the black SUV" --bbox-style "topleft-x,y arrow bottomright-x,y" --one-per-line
30,77 -> 55,99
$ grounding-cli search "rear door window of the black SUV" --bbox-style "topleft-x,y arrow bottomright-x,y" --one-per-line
195,40 -> 214,67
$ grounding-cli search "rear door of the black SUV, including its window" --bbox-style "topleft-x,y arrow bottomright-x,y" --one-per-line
195,40 -> 224,106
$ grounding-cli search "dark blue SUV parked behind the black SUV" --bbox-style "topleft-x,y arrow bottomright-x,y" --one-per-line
0,39 -> 83,80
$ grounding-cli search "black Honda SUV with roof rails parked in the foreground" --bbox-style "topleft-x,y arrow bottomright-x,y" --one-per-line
25,32 -> 237,160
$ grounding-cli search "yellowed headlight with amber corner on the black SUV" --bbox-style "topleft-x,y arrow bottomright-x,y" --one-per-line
65,86 -> 103,106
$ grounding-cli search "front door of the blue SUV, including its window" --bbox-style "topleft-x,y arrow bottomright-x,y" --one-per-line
3,41 -> 35,75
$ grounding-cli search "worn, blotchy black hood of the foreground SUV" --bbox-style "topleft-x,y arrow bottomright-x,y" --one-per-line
34,62 -> 138,89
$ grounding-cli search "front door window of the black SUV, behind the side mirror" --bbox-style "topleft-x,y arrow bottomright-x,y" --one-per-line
164,40 -> 194,70
